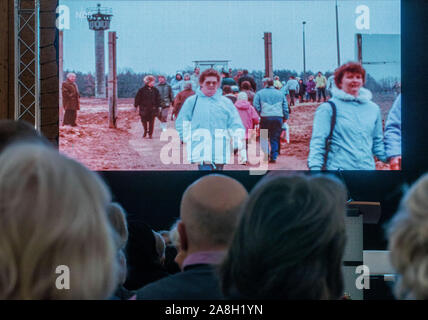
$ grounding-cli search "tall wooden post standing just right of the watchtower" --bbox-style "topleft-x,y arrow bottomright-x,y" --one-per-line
107,32 -> 117,128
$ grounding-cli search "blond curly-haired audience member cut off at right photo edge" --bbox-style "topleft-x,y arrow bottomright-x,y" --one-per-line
388,174 -> 428,300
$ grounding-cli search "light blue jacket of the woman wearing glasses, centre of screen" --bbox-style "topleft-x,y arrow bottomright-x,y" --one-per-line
175,89 -> 245,164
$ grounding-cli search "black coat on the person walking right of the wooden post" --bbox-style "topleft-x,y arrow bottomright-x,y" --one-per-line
134,85 -> 162,121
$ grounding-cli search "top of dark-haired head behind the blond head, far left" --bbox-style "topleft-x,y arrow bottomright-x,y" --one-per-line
0,119 -> 51,152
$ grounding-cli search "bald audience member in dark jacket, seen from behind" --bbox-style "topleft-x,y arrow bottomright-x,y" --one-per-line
137,175 -> 247,300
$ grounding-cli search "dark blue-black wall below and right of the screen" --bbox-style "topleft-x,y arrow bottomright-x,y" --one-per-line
100,0 -> 428,250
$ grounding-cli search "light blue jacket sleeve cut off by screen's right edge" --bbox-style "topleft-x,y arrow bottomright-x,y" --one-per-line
384,94 -> 401,158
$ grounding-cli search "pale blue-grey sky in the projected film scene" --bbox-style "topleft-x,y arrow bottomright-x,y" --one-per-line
60,0 -> 401,75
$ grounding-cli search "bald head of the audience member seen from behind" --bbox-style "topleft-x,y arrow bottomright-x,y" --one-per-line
180,175 -> 248,249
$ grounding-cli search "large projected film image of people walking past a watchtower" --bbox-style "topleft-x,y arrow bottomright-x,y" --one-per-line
57,0 -> 401,174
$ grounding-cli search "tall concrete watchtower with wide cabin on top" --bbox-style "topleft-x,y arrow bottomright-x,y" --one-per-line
86,4 -> 113,98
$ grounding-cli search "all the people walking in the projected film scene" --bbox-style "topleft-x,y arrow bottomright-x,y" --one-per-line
62,62 -> 401,170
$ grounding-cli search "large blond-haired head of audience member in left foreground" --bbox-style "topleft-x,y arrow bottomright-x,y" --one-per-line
0,143 -> 117,300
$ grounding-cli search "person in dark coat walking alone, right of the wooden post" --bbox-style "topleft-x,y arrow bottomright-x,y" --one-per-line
134,75 -> 162,139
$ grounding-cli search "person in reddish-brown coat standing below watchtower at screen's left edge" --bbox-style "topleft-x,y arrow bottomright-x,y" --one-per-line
61,73 -> 80,127
